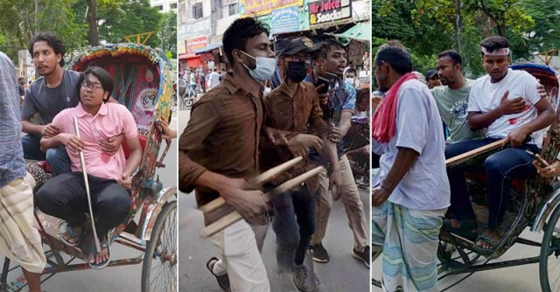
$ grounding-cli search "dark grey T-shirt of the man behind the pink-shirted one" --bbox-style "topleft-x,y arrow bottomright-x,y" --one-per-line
21,70 -> 80,125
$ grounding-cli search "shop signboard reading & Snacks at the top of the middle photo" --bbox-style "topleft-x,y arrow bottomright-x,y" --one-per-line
307,0 -> 352,26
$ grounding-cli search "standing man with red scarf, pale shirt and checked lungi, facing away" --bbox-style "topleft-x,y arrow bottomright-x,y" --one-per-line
372,42 -> 450,291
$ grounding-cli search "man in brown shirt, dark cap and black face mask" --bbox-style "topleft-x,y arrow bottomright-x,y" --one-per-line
261,37 -> 337,291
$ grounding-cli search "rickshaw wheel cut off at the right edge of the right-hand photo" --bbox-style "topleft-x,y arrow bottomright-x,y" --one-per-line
539,207 -> 560,292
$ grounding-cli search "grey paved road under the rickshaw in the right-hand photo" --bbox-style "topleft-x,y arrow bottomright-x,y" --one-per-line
372,229 -> 544,292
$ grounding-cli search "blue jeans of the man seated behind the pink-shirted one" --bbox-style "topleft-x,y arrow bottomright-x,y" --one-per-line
21,134 -> 71,176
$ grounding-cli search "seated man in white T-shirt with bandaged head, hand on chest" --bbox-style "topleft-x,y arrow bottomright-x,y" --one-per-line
445,36 -> 555,254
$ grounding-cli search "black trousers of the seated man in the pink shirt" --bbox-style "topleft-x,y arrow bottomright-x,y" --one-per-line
35,172 -> 130,240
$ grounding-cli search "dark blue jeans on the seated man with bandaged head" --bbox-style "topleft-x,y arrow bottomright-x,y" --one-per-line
445,138 -> 540,229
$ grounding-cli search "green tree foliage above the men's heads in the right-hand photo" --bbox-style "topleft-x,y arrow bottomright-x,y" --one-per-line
372,0 -> 560,77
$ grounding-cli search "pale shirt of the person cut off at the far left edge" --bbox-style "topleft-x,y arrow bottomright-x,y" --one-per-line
0,52 -> 26,188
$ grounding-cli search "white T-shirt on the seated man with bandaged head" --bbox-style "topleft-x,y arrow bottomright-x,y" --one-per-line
468,69 -> 544,148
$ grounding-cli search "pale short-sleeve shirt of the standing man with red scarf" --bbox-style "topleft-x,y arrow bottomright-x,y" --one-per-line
372,80 -> 451,210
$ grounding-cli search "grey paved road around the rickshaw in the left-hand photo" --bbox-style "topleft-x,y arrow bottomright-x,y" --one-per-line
0,115 -> 177,292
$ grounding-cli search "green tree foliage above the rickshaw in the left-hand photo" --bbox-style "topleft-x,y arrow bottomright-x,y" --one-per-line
0,0 -> 177,62
